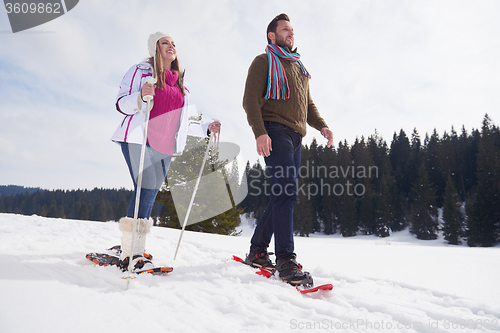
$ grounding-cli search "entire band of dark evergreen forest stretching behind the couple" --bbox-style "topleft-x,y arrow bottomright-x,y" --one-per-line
0,115 -> 500,247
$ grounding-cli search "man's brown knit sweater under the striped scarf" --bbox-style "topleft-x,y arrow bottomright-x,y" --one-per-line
243,53 -> 328,138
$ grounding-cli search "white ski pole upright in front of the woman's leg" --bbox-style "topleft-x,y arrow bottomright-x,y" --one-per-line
123,77 -> 156,282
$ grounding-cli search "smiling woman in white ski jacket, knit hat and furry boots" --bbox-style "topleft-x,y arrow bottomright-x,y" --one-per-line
112,32 -> 220,270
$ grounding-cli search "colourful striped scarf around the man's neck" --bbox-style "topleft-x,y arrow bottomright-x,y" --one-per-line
265,44 -> 311,100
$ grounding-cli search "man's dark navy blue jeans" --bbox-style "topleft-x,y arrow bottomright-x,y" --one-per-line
250,121 -> 302,258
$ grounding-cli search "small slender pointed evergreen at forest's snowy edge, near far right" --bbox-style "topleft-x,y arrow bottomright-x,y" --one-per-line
442,175 -> 463,245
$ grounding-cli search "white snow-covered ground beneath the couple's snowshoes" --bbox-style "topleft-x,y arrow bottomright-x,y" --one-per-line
0,214 -> 500,333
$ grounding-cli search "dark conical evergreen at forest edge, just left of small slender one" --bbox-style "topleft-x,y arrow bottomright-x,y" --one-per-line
410,163 -> 438,240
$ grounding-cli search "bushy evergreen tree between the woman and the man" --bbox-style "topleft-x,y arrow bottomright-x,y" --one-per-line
156,137 -> 243,235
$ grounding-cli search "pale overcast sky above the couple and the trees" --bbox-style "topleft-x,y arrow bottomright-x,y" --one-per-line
0,0 -> 500,189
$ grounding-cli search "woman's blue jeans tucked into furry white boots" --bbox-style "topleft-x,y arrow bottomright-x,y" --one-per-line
121,142 -> 172,218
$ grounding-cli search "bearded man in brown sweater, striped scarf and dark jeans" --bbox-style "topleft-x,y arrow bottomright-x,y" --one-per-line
243,14 -> 333,285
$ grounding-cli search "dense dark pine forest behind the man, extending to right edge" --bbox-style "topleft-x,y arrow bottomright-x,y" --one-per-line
242,115 -> 500,246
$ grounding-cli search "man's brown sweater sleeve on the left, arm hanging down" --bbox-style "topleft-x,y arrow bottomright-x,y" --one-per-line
243,54 -> 268,138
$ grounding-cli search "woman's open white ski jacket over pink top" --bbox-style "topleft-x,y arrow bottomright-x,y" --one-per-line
111,62 -> 209,156
